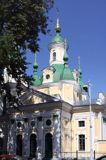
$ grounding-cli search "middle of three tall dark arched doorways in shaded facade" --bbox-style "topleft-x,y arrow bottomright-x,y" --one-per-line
30,134 -> 37,157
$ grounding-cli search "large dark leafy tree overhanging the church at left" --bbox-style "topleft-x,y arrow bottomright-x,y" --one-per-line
0,0 -> 53,112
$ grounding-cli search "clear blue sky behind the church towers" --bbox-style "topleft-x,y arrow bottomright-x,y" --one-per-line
28,0 -> 106,98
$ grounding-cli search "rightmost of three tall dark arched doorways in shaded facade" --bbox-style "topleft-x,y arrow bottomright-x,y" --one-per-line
45,133 -> 53,158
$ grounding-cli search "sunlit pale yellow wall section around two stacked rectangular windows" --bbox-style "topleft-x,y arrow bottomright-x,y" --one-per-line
71,112 -> 90,152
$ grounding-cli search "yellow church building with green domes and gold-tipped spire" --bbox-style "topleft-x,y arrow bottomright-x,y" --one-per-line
0,19 -> 106,160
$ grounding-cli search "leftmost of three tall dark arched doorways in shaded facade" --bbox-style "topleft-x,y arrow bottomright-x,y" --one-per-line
16,134 -> 22,156
